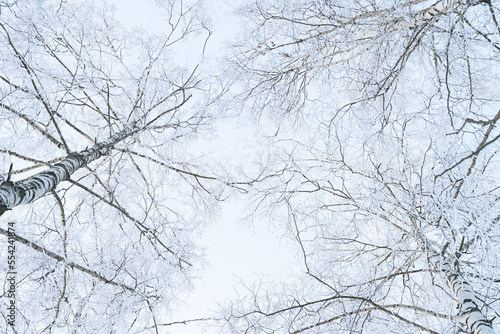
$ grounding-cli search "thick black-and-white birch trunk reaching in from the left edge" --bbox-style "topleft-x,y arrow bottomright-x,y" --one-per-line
0,123 -> 140,216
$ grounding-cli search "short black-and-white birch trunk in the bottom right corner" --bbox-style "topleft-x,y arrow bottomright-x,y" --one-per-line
430,254 -> 495,334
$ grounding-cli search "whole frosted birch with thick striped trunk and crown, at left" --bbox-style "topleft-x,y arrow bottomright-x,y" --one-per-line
0,0 -> 223,333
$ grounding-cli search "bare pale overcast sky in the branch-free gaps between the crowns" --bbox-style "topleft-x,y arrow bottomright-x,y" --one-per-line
105,0 -> 300,334
